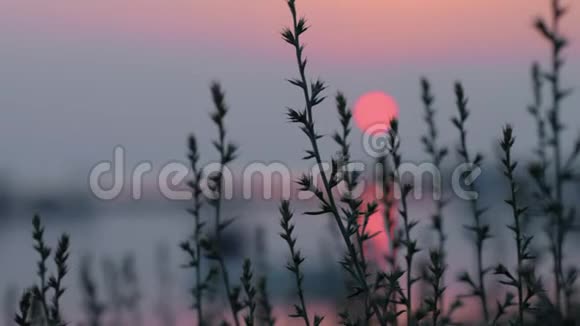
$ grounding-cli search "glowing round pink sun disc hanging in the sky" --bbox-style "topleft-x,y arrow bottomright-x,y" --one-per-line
354,91 -> 399,133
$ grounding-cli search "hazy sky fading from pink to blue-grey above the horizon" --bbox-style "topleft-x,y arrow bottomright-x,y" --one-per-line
0,0 -> 580,183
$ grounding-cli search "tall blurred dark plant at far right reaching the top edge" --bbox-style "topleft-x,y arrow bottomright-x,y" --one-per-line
529,0 -> 580,313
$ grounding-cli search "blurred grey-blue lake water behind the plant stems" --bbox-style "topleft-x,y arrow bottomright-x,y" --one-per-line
0,192 -> 572,325
